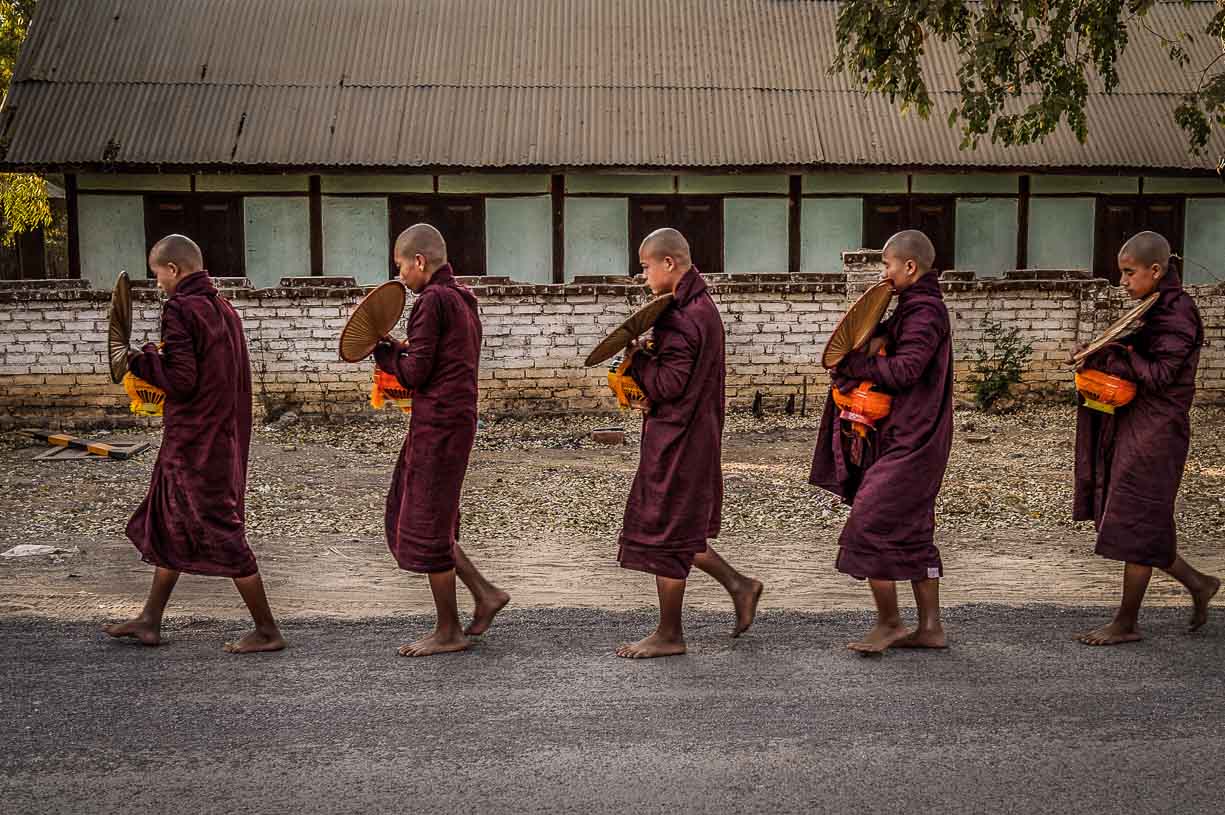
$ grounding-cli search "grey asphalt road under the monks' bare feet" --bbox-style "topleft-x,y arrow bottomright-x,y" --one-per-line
0,605 -> 1225,815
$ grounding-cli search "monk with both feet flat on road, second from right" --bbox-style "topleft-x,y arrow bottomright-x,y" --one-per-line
810,229 -> 953,653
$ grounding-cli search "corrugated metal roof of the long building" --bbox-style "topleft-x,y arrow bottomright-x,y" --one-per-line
0,0 -> 1225,168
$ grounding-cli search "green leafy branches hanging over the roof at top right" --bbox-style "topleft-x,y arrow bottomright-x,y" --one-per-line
831,0 -> 1225,153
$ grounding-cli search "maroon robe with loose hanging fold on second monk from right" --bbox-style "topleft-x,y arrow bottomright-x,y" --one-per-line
809,273 -> 953,580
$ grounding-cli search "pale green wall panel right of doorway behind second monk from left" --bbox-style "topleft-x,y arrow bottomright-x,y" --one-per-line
485,195 -> 552,283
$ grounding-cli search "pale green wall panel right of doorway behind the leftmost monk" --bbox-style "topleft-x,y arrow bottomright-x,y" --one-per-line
243,196 -> 310,288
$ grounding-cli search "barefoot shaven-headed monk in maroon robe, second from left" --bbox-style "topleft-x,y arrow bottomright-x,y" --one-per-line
375,223 -> 511,657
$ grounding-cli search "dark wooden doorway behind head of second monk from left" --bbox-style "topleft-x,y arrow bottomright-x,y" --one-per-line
387,195 -> 485,277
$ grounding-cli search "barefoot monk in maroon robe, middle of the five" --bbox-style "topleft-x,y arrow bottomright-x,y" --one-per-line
616,229 -> 762,659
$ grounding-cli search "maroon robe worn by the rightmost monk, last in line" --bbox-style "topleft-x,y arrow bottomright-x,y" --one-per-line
1072,268 -> 1204,569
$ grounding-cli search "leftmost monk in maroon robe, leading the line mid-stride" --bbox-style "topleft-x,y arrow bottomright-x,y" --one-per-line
103,235 -> 285,653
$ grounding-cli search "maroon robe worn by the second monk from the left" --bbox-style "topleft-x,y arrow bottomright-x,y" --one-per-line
375,265 -> 481,572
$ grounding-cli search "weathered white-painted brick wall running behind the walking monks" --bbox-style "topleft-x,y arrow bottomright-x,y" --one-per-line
0,251 -> 1225,426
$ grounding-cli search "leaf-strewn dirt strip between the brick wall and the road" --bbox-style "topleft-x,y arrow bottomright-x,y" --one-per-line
0,407 -> 1225,616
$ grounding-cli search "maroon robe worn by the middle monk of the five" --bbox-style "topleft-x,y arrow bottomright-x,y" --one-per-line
617,267 -> 724,580
